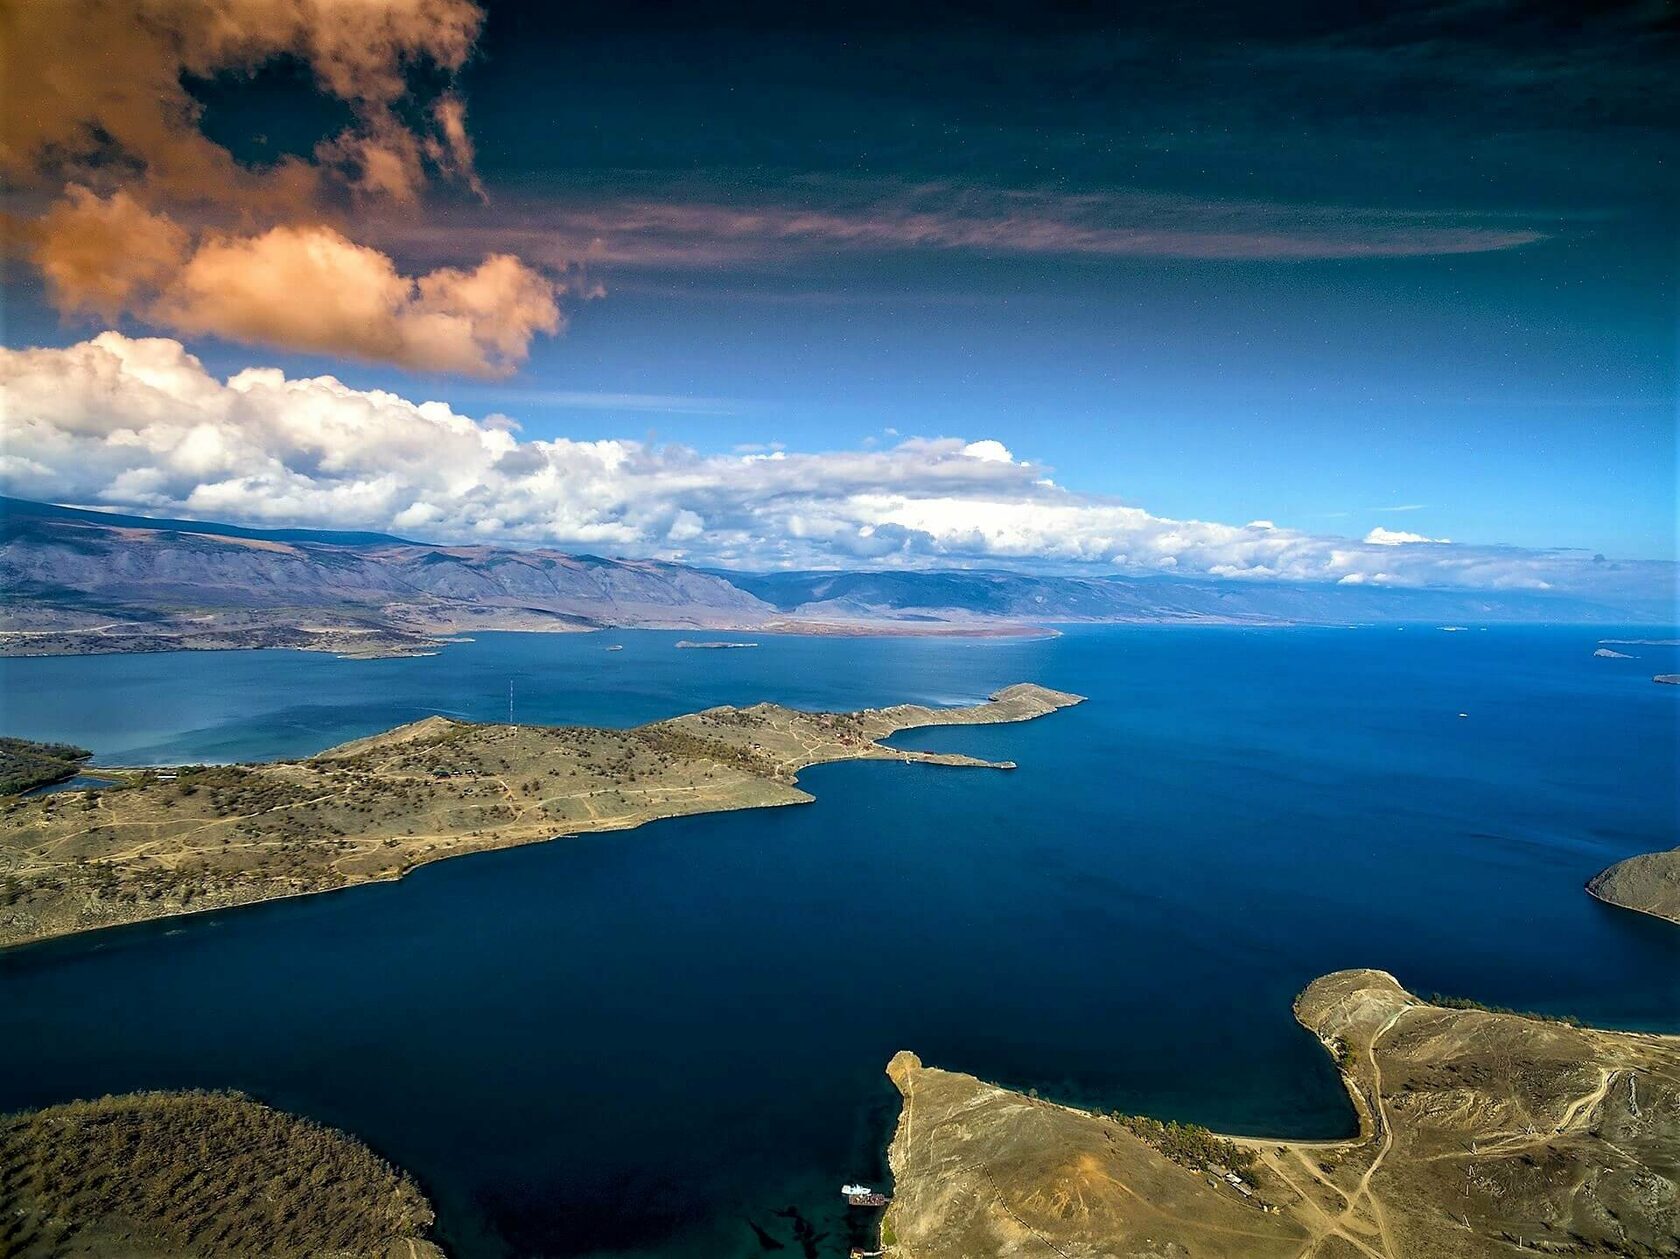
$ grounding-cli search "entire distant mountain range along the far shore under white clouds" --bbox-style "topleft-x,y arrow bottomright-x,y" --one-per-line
0,499 -> 1635,656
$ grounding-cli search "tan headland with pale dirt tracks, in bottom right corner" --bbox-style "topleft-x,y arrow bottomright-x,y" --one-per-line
882,970 -> 1680,1259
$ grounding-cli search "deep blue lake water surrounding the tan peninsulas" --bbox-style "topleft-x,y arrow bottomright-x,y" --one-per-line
0,627 -> 1680,1259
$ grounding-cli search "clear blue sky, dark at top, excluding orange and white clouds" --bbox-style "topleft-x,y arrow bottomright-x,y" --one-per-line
5,0 -> 1677,591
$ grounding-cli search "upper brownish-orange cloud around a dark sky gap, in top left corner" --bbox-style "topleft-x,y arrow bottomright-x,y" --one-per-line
0,0 -> 484,208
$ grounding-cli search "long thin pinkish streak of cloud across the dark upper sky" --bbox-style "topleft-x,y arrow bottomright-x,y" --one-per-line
393,176 -> 1544,267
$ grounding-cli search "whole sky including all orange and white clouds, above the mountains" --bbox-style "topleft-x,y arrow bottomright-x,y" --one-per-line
0,0 -> 1680,592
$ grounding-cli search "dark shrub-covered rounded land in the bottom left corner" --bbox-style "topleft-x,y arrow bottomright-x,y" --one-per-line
0,1093 -> 444,1259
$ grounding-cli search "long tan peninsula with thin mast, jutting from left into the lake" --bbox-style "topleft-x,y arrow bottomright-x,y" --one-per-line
0,684 -> 1082,946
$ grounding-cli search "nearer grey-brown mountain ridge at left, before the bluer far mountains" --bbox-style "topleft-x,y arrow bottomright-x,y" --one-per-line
0,499 -> 773,654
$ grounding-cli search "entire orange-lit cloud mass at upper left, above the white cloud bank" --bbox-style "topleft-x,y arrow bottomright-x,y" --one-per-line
0,0 -> 564,375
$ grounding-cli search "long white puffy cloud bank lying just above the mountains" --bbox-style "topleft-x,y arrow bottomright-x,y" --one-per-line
0,333 -> 1673,605
